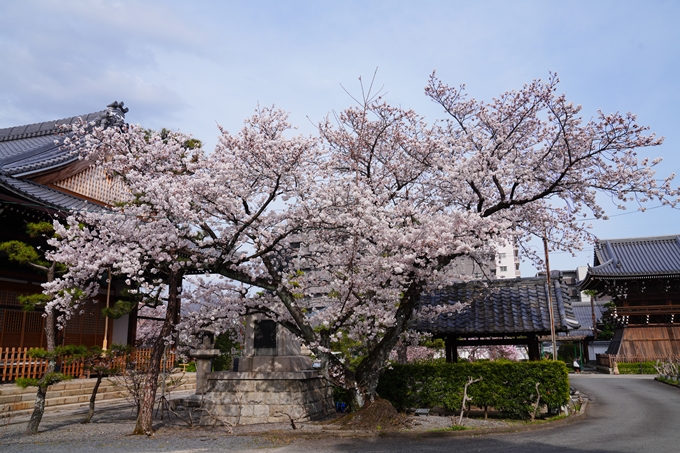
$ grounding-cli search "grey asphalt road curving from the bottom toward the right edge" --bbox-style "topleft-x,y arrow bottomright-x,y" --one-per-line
272,375 -> 680,453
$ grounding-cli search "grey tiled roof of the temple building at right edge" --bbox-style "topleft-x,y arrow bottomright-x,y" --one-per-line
586,236 -> 680,280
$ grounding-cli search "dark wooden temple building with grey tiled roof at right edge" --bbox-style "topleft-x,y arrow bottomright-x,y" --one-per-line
580,236 -> 680,366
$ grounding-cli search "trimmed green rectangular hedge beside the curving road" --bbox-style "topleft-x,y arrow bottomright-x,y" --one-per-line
377,360 -> 569,418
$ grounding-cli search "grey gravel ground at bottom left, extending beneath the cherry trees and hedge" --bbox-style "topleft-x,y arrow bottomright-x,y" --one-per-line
0,406 -> 515,453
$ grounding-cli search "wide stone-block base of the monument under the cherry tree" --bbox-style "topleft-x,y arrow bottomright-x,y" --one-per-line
201,371 -> 335,425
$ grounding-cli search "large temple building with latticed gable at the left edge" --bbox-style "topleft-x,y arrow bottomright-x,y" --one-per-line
0,102 -> 136,348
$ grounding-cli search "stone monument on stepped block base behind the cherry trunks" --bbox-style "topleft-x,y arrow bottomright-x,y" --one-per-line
196,315 -> 335,425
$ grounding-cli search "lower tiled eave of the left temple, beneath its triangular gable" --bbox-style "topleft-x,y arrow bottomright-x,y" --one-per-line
0,175 -> 107,212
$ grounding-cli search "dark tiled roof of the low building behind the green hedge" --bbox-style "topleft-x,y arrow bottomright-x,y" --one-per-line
416,277 -> 579,337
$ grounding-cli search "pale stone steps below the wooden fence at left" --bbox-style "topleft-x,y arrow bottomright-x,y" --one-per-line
0,373 -> 196,417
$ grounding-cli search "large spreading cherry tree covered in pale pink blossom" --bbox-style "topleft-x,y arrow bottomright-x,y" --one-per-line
49,74 -> 678,416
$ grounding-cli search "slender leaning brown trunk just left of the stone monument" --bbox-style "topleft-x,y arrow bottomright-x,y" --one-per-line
132,271 -> 182,436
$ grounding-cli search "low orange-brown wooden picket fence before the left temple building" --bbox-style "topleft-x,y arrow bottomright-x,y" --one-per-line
0,348 -> 175,382
